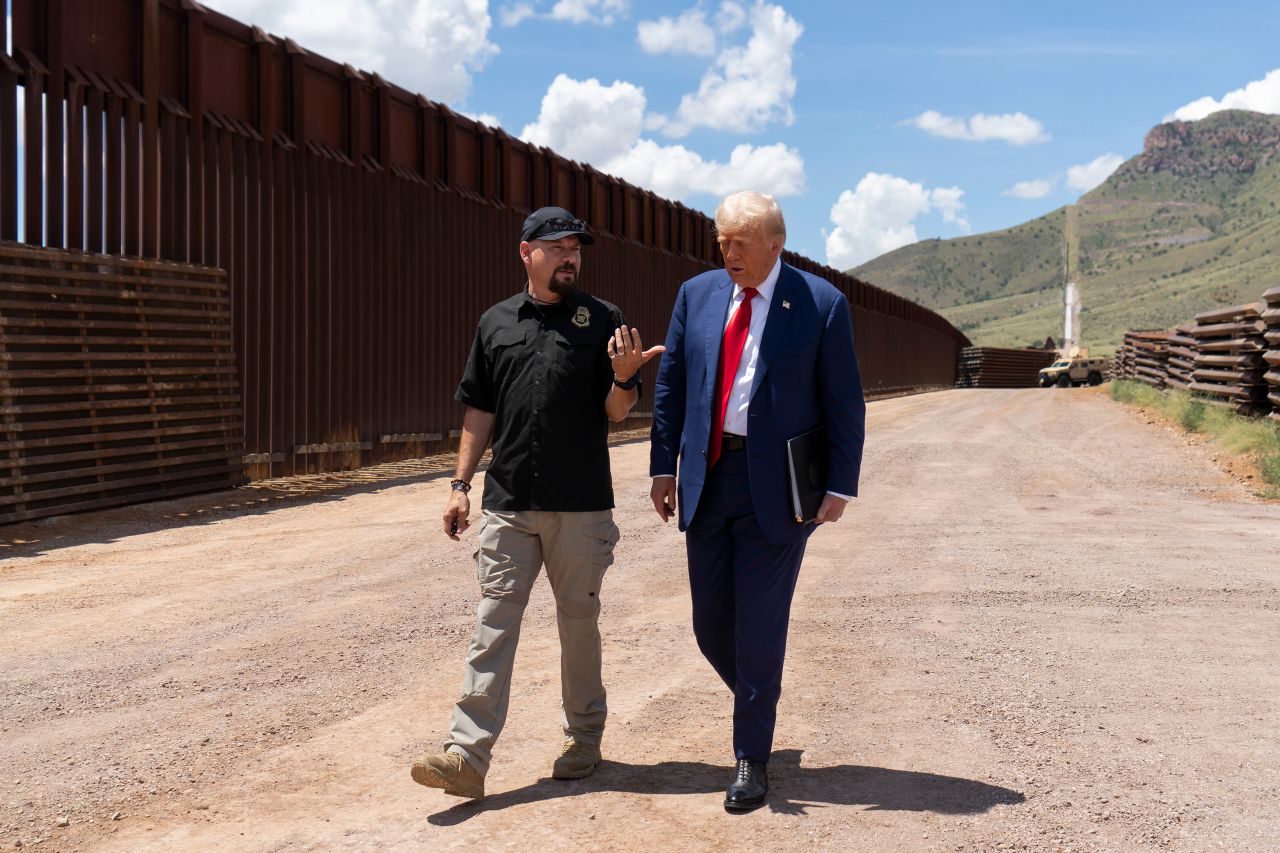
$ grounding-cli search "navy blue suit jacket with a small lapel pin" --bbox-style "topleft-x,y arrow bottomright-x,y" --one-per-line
649,264 -> 867,544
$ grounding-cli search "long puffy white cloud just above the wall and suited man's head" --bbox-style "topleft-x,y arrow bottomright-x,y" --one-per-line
521,74 -> 805,200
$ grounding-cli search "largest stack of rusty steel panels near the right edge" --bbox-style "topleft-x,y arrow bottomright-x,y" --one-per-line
1190,302 -> 1271,415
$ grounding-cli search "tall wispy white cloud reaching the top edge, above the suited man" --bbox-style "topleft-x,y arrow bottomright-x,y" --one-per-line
650,0 -> 804,138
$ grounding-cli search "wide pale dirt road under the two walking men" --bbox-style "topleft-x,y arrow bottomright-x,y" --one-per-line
0,391 -> 1280,850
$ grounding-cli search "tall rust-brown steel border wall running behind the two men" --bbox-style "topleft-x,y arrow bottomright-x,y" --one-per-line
0,0 -> 968,476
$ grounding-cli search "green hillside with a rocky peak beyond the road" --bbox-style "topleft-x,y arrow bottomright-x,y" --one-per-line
850,110 -> 1280,353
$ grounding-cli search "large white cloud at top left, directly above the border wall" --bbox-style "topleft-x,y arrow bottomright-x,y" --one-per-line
206,0 -> 498,104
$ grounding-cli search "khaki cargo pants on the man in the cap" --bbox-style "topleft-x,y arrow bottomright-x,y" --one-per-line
445,510 -> 618,775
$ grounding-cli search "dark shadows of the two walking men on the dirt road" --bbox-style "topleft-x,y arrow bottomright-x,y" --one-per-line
428,749 -> 1025,826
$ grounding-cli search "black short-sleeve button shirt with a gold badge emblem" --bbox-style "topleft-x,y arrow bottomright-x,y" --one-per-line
453,289 -> 623,512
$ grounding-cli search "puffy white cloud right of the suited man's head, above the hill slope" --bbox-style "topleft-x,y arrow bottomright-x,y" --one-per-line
826,172 -> 969,269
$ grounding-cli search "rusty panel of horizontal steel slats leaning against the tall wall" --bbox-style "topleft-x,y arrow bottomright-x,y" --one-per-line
0,235 -> 244,524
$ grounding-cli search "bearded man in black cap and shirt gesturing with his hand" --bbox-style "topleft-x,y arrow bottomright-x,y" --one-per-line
412,207 -> 664,797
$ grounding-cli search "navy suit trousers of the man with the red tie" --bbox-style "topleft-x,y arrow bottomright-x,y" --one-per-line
685,451 -> 812,761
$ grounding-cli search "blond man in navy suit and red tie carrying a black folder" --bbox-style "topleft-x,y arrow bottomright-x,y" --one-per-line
649,192 -> 867,811
